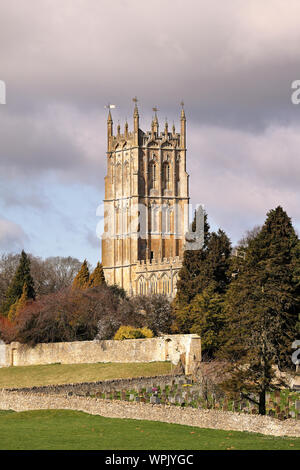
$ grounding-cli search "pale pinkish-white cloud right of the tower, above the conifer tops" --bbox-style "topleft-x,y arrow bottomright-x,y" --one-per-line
187,126 -> 300,240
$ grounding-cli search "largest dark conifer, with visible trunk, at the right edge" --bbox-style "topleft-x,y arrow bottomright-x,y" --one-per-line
221,207 -> 300,414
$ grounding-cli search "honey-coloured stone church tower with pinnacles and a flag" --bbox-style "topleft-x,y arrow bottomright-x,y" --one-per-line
102,99 -> 189,297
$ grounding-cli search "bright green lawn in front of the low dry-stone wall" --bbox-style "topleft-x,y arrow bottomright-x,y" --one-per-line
0,410 -> 300,450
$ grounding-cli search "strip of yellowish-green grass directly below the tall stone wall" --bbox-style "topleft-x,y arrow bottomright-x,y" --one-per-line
0,362 -> 174,388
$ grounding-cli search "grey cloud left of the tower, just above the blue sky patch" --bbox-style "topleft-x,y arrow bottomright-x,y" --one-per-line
0,106 -> 105,185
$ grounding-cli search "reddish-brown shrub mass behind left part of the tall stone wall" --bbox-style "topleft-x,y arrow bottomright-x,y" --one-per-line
0,285 -> 143,346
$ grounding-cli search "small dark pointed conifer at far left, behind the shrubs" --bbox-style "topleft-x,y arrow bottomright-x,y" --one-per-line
2,250 -> 35,315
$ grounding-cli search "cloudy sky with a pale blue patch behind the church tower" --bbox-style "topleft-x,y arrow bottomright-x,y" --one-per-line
0,0 -> 300,265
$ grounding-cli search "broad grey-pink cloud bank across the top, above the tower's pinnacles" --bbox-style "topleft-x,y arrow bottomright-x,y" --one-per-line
0,0 -> 300,128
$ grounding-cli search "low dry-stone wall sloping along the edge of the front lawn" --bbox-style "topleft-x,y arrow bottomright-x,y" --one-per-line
0,390 -> 300,437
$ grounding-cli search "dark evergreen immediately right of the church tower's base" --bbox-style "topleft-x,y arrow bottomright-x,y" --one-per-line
173,222 -> 231,348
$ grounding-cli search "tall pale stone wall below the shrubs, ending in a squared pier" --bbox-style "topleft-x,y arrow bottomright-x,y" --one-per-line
0,335 -> 201,374
